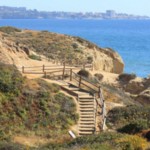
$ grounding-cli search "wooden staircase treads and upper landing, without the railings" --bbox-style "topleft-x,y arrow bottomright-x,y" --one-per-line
61,81 -> 96,136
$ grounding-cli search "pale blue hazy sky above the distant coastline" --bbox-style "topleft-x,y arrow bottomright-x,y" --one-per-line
0,0 -> 150,16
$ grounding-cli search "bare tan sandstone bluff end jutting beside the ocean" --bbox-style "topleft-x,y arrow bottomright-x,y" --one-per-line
74,37 -> 124,74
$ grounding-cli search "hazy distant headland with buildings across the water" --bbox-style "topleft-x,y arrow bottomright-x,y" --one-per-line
0,6 -> 150,19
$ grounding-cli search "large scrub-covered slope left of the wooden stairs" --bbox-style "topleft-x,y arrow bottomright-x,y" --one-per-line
0,63 -> 79,143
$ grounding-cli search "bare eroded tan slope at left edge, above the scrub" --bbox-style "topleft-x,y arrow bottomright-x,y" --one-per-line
0,35 -> 30,66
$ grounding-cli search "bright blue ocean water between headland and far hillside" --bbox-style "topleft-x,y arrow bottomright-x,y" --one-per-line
0,20 -> 150,77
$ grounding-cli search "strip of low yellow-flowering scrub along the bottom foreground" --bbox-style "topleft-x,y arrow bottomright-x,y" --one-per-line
1,132 -> 149,150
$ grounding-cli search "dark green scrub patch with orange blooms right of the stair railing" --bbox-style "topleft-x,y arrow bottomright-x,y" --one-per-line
107,106 -> 150,134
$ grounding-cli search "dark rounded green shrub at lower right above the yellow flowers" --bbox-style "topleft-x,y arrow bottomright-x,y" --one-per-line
118,120 -> 148,134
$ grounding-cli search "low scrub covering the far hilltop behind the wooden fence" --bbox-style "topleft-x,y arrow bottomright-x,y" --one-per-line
0,27 -> 94,64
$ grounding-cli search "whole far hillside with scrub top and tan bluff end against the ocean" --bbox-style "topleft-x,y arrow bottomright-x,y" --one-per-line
0,27 -> 124,74
